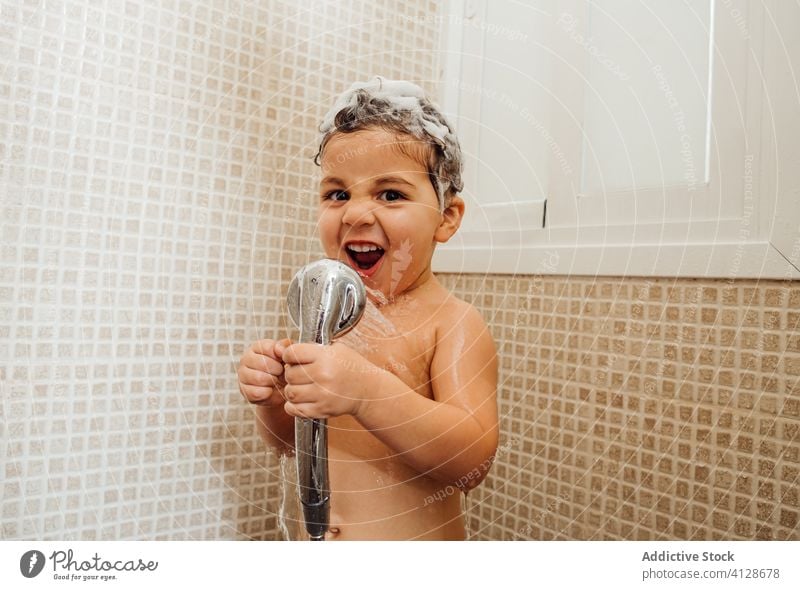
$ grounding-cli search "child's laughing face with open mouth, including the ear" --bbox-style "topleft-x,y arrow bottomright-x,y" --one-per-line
319,128 -> 463,297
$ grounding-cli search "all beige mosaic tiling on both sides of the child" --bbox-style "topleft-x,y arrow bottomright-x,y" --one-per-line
0,0 -> 800,540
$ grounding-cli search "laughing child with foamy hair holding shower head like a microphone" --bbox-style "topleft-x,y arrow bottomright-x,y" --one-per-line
239,78 -> 498,540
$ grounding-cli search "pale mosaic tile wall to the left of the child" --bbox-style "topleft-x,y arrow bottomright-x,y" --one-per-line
0,0 -> 436,540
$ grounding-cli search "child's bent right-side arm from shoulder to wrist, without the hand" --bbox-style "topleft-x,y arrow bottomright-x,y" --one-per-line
356,307 -> 499,489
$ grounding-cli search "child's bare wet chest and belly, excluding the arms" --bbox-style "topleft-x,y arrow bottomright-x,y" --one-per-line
326,284 -> 465,540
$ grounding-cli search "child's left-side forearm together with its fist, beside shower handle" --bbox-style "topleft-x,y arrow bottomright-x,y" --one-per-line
238,340 -> 294,453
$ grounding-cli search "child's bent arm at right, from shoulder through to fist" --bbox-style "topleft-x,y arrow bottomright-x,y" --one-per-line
284,307 -> 498,489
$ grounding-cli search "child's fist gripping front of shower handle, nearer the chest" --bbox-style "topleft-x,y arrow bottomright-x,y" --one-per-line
283,342 -> 384,418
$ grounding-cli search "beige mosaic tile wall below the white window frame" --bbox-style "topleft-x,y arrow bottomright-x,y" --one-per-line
441,275 -> 800,540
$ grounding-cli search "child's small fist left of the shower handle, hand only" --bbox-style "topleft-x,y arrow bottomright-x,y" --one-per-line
239,339 -> 291,407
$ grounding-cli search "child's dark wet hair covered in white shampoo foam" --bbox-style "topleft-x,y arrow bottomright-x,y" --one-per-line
314,76 -> 464,210
